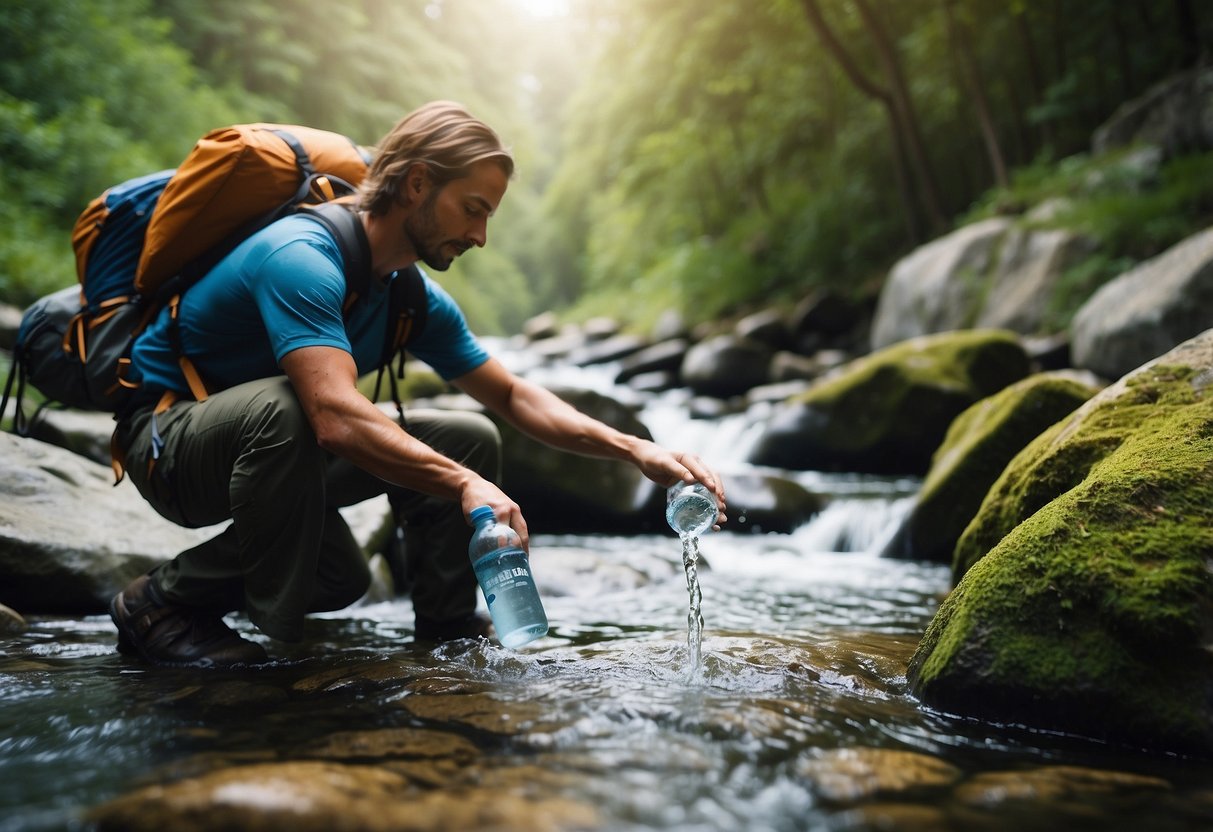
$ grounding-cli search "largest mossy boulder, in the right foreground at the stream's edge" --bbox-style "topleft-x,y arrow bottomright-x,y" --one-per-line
907,330 -> 1213,754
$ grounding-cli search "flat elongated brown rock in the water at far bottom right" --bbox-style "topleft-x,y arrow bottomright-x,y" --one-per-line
953,765 -> 1171,809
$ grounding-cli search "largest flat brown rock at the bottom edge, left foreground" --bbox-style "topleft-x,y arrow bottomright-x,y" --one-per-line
89,762 -> 597,832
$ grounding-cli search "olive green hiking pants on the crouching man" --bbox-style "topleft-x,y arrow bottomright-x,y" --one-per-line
118,377 -> 501,640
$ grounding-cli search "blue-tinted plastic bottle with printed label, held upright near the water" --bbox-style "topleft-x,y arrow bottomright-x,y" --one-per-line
467,506 -> 547,648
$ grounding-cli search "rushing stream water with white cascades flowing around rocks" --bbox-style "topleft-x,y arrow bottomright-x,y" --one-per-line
0,342 -> 1213,832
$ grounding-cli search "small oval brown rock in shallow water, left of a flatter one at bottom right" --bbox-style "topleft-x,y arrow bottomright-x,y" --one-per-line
797,748 -> 961,804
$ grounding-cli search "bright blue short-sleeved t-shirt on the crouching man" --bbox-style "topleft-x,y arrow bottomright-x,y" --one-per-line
131,215 -> 489,394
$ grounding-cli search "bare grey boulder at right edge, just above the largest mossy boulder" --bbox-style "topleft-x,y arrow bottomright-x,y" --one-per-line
1071,228 -> 1213,378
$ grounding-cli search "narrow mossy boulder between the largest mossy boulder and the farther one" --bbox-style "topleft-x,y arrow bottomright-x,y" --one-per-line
887,372 -> 1098,563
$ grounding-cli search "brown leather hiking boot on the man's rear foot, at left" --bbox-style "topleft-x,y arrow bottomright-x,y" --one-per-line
109,575 -> 268,667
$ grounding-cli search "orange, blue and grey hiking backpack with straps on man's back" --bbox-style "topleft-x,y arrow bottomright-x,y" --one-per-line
0,124 -> 427,443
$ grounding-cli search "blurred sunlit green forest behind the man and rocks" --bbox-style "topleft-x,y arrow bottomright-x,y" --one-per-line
0,0 -> 1213,334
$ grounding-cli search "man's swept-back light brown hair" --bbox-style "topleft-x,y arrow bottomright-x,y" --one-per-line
358,101 -> 514,213
